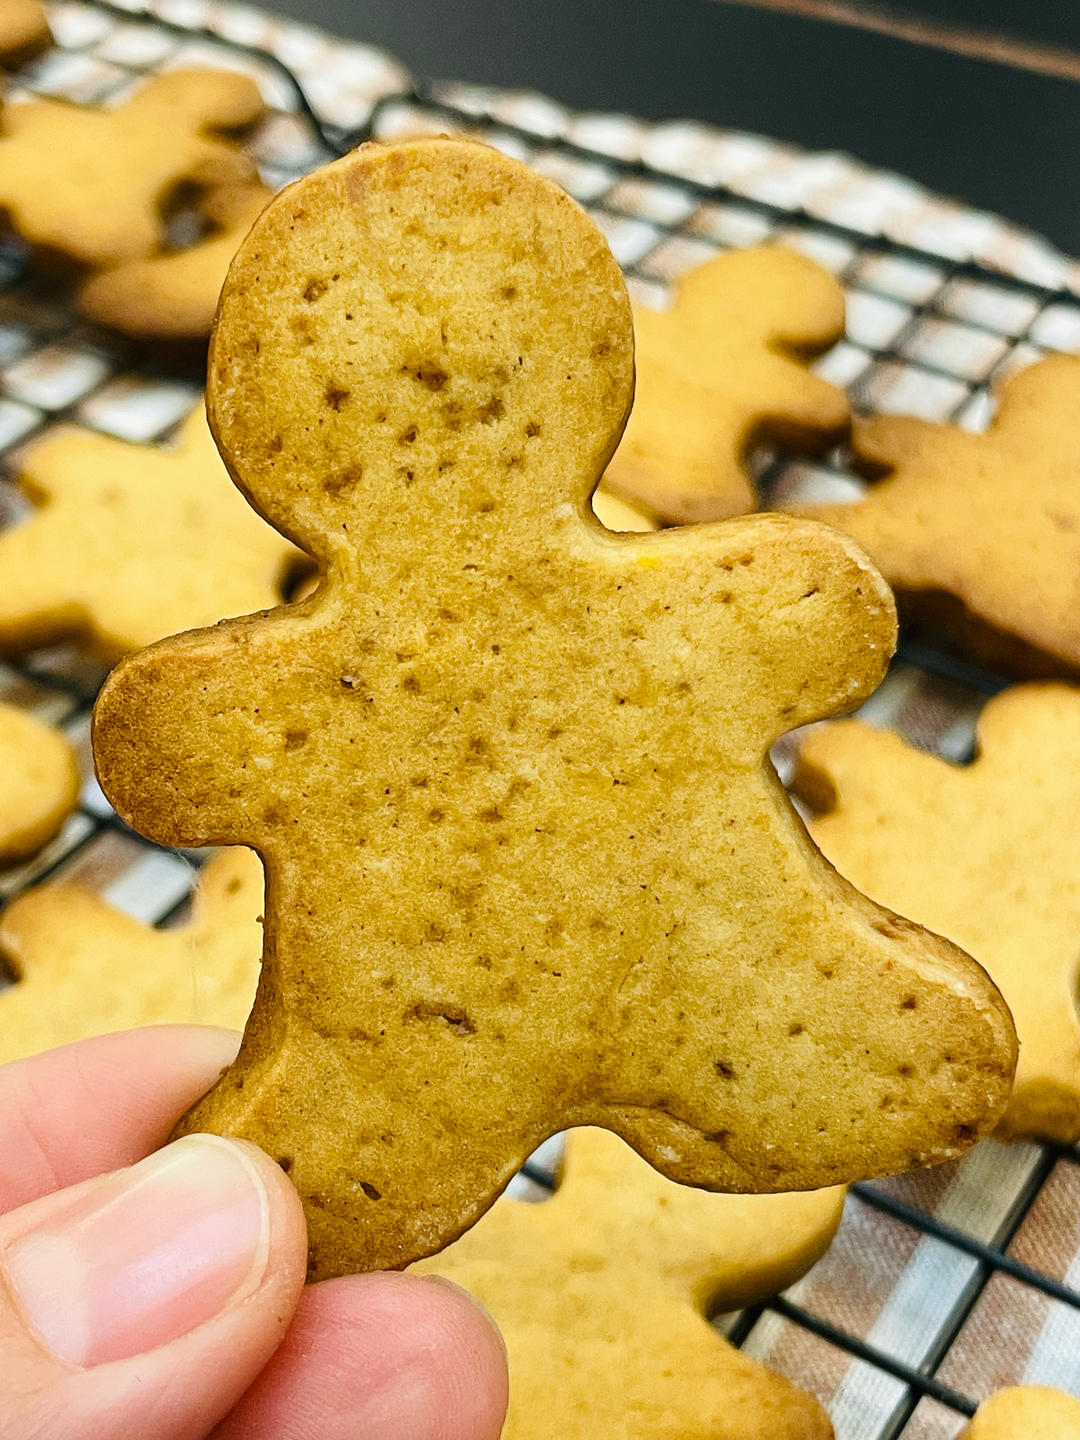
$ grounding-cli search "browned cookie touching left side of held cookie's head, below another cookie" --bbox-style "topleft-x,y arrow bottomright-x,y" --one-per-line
78,184 -> 272,340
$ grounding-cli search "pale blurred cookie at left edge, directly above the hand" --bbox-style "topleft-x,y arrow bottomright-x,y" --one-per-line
0,850 -> 264,1064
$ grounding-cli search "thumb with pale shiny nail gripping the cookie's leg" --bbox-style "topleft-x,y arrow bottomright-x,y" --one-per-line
0,1135 -> 307,1440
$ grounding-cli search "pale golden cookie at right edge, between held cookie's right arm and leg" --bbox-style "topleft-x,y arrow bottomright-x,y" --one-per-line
795,685 -> 1080,1143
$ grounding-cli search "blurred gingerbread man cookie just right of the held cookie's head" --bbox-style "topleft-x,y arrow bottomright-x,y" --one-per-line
603,245 -> 850,524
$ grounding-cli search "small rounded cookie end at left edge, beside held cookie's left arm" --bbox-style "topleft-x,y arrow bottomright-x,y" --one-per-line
0,704 -> 81,865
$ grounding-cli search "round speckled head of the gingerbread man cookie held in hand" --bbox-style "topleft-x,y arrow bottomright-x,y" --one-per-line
210,140 -> 632,550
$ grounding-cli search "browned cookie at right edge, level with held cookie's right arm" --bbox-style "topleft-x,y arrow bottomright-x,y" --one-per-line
804,356 -> 1080,675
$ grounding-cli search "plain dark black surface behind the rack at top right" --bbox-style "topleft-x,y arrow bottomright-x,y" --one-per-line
262,0 -> 1080,253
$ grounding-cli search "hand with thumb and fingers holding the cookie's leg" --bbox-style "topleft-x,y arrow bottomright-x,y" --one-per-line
0,1025 -> 507,1440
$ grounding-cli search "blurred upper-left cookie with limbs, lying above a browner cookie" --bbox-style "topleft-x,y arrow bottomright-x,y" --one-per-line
0,69 -> 264,268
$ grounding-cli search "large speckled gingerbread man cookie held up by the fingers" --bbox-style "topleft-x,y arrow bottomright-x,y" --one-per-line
95,140 -> 1014,1276
